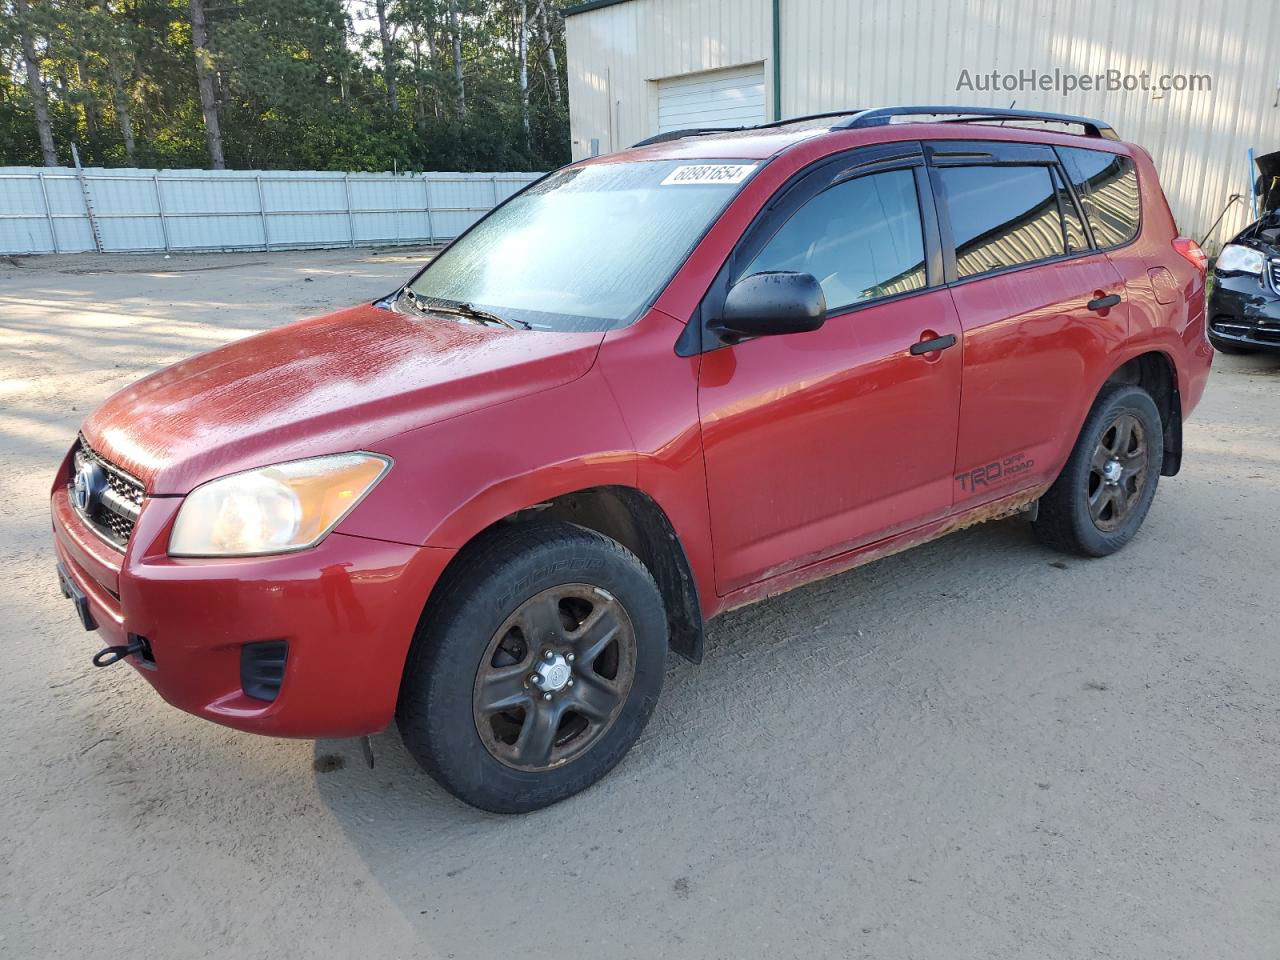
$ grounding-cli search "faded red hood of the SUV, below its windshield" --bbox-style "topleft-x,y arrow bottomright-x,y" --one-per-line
82,306 -> 604,495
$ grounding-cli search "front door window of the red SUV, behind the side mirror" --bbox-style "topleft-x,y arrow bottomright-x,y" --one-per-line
740,170 -> 924,310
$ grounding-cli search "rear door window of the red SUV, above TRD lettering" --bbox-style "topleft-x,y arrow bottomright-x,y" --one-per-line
938,166 -> 1066,276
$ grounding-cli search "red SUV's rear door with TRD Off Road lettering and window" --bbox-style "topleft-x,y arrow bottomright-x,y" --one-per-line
925,141 -> 1128,508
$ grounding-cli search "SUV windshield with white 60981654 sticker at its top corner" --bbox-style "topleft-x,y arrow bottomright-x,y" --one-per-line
408,160 -> 755,330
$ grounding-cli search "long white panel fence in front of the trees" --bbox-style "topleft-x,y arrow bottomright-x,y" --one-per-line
0,166 -> 541,255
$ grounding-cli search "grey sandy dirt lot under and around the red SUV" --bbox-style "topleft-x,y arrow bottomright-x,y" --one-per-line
0,251 -> 1280,960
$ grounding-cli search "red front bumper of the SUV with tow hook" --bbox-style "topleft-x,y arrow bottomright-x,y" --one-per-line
52,486 -> 454,737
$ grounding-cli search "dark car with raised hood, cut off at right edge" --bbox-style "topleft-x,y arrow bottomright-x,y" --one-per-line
1208,151 -> 1280,353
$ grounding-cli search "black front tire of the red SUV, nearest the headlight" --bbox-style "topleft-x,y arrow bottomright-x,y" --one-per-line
396,521 -> 667,813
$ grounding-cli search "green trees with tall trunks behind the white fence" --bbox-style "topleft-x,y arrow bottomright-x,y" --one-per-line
0,0 -> 570,170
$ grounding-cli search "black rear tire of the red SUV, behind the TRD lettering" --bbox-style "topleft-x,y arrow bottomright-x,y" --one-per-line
1033,384 -> 1165,557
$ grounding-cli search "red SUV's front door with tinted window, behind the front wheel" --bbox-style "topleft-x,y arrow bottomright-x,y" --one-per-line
699,152 -> 961,594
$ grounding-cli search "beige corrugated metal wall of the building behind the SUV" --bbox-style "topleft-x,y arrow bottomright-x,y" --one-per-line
567,0 -> 1280,246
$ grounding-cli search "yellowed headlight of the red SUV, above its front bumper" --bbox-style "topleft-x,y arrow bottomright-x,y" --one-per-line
169,453 -> 392,557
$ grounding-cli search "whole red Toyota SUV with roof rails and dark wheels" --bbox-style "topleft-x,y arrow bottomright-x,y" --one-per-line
52,108 -> 1212,812
